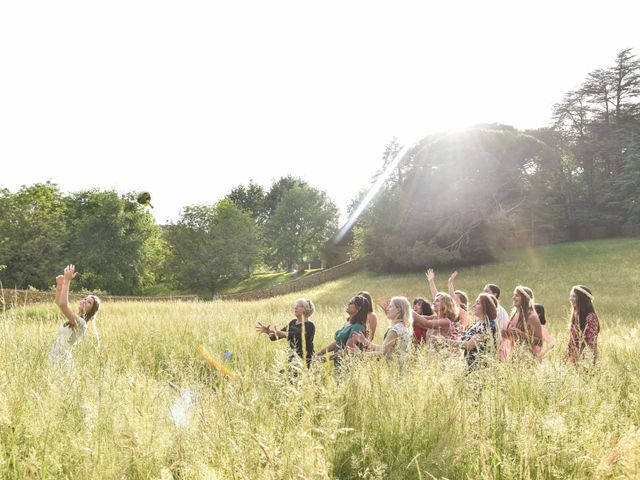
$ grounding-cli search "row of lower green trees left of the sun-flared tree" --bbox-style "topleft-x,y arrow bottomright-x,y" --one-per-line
0,177 -> 338,295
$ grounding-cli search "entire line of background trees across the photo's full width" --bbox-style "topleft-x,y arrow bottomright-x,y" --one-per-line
0,49 -> 640,294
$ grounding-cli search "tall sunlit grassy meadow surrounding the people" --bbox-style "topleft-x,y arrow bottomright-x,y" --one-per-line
0,238 -> 640,480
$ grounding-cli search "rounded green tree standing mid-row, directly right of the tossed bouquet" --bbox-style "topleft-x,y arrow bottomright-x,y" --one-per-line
166,199 -> 259,293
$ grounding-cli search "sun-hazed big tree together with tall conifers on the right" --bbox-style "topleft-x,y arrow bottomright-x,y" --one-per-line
352,49 -> 640,270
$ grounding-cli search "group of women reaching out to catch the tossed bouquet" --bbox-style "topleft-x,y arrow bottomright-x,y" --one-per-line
256,269 -> 600,367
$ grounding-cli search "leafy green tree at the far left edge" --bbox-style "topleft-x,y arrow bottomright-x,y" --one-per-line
0,182 -> 67,289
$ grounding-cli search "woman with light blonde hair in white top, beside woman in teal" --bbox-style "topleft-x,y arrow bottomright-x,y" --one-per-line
353,297 -> 412,361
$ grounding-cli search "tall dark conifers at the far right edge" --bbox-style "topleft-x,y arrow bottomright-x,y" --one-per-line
553,49 -> 640,235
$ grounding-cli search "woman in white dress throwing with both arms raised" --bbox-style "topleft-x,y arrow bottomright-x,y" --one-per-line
49,265 -> 100,368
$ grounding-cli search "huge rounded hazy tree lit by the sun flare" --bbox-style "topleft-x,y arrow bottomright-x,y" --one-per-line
355,125 -> 549,270
